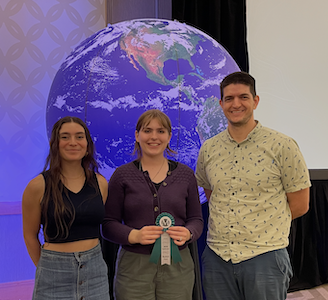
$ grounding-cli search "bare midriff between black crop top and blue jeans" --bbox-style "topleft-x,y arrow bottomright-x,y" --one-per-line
43,238 -> 99,252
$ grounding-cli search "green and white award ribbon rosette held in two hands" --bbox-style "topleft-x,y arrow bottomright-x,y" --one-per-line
149,213 -> 182,265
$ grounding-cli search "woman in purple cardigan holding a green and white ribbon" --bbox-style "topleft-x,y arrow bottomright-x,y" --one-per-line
102,109 -> 203,300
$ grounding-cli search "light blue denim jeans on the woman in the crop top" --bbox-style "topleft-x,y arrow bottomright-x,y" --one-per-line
33,244 -> 109,300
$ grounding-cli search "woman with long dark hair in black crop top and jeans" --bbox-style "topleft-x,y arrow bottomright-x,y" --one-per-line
22,117 -> 109,300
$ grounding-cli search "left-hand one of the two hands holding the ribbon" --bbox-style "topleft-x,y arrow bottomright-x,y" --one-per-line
128,226 -> 163,245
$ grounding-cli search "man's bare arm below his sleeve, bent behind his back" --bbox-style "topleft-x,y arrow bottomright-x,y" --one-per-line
286,188 -> 310,219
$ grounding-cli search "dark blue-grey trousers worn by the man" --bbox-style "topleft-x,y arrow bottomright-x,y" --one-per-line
202,246 -> 292,300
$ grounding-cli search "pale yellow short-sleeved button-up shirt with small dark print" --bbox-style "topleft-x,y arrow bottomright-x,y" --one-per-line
196,123 -> 311,263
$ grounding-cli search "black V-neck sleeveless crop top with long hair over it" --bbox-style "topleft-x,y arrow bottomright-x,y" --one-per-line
41,172 -> 105,243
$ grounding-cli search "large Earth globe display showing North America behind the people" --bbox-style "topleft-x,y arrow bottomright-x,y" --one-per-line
46,19 -> 239,184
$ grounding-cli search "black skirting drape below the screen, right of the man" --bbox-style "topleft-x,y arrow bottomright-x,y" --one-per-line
288,180 -> 328,291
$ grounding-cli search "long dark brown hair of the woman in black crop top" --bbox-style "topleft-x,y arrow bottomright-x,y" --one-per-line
41,116 -> 98,240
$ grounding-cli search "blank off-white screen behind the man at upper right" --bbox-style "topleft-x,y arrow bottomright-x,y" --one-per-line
246,0 -> 328,169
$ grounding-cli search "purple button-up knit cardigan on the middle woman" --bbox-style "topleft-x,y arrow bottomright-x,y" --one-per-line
102,162 -> 203,254
